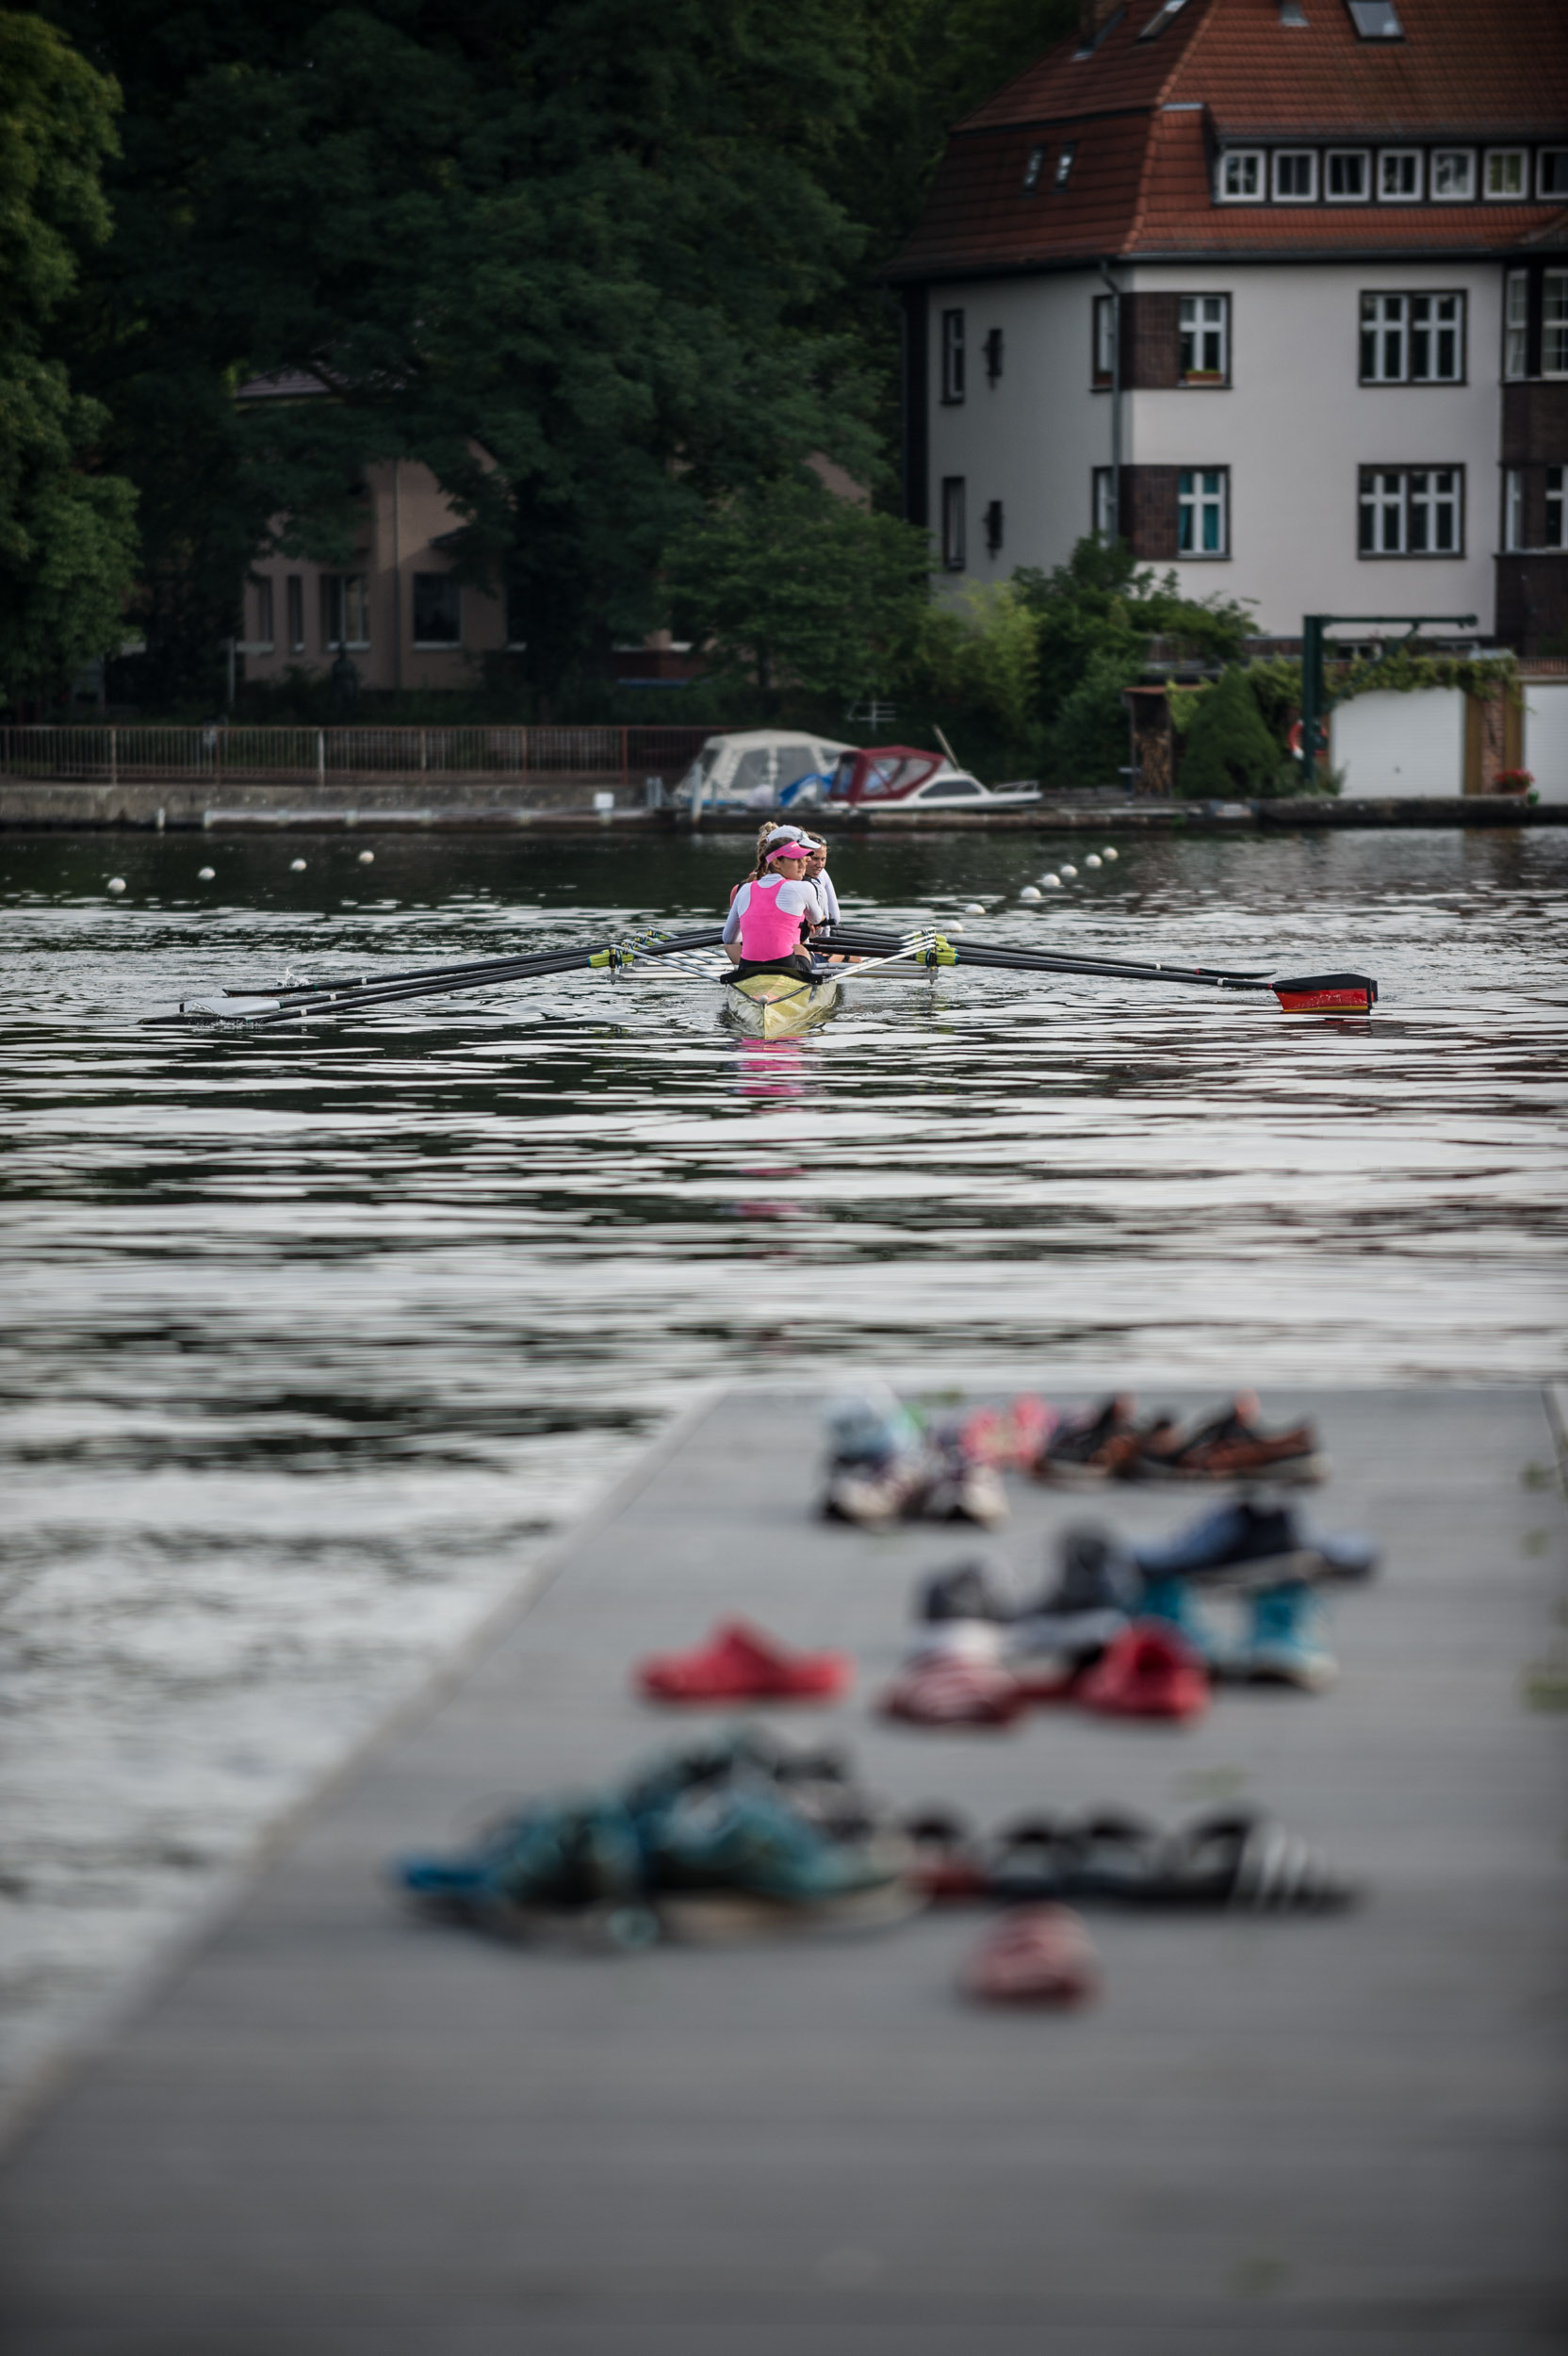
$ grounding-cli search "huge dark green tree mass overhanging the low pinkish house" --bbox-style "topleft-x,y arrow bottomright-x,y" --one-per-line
40,0 -> 878,681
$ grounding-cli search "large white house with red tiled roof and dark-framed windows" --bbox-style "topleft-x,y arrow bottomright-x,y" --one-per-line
892,0 -> 1568,648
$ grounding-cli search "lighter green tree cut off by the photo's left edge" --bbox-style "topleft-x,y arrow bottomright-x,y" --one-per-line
0,14 -> 134,697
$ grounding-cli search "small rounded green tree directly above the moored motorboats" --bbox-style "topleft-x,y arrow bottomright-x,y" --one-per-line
666,469 -> 930,705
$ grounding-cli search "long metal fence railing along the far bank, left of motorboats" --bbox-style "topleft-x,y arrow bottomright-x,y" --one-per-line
0,721 -> 726,787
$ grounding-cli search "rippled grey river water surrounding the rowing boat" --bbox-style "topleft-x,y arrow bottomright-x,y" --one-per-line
0,832 -> 1568,2102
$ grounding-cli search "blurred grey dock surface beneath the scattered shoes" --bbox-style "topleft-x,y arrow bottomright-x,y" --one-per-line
0,1390 -> 1568,2356
